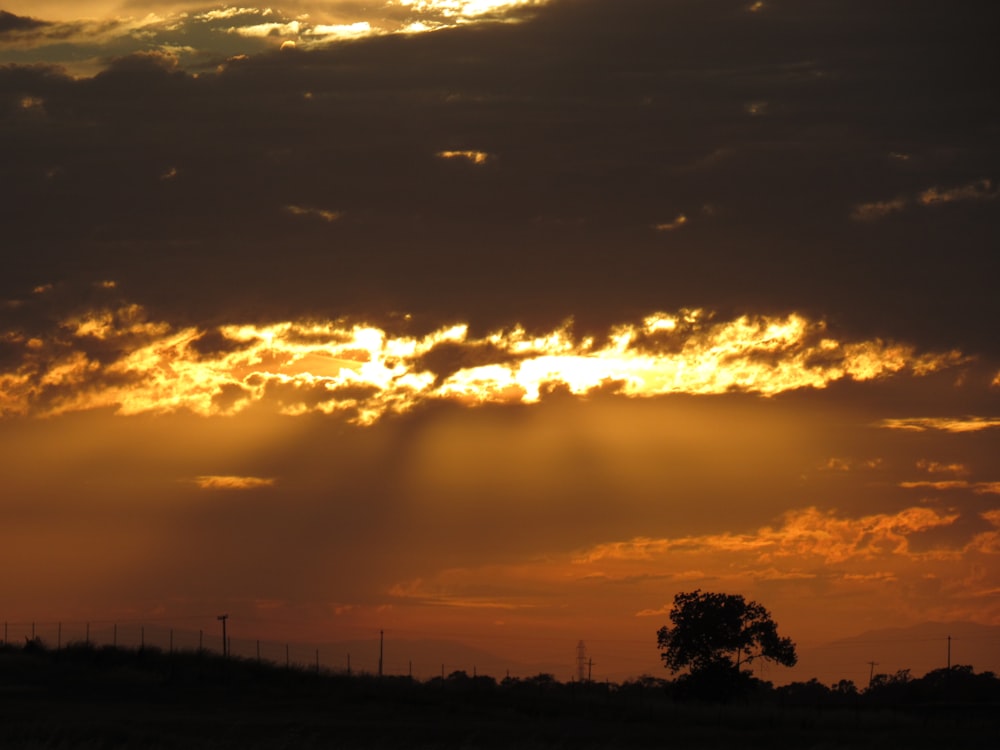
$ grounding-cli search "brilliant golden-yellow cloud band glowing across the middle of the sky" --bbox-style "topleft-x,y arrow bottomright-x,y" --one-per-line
0,304 -> 968,429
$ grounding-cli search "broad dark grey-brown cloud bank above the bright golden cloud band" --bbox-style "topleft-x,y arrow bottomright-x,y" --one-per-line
0,0 -> 1000,354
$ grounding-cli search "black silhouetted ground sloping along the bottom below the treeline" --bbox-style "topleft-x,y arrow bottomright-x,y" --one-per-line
0,647 -> 1000,750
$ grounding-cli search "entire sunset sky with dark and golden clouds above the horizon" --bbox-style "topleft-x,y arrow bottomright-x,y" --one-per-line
0,0 -> 1000,683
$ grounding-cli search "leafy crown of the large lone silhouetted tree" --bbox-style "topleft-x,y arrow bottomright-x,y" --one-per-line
656,589 -> 798,674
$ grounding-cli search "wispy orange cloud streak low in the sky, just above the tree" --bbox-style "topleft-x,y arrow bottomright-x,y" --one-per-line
376,507 -> 1000,627
